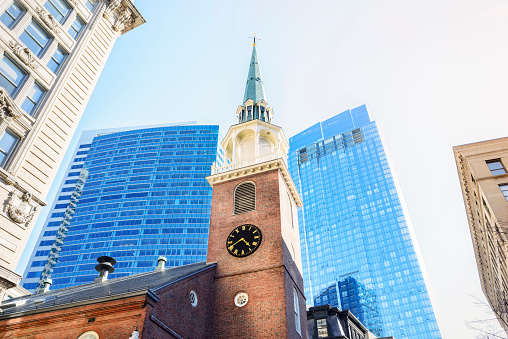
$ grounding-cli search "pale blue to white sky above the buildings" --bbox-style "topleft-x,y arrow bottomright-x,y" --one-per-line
18,0 -> 508,339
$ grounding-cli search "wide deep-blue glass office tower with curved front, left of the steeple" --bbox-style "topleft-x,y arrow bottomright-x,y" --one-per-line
23,124 -> 223,291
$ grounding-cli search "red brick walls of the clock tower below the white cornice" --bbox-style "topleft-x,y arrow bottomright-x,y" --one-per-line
207,169 -> 307,338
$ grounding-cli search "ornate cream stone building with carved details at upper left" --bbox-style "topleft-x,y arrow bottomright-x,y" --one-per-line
0,0 -> 145,300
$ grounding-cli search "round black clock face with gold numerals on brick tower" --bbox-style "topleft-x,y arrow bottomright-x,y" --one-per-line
226,225 -> 262,257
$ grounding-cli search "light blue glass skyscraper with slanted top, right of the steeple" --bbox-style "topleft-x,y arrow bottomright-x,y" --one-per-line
289,106 -> 441,339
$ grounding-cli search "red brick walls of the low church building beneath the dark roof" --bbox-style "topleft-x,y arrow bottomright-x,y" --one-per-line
0,267 -> 215,339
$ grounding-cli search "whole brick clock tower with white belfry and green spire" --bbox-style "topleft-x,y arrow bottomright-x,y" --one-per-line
207,41 -> 308,338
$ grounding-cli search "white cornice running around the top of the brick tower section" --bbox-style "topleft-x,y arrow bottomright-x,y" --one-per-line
206,158 -> 303,207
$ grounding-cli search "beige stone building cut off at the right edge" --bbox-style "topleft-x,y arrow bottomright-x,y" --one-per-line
453,138 -> 508,334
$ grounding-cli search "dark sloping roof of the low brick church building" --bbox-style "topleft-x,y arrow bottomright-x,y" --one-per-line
0,262 -> 217,319
